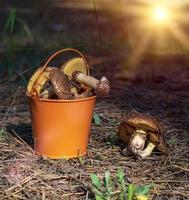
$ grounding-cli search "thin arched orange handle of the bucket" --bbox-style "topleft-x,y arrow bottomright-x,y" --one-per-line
31,48 -> 89,96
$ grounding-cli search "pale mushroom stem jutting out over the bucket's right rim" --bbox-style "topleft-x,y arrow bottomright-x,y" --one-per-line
72,71 -> 110,95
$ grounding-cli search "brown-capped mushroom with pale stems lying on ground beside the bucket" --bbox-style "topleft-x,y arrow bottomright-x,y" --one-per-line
118,114 -> 167,159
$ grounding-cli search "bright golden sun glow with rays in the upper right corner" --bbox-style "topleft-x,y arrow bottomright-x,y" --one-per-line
127,1 -> 189,55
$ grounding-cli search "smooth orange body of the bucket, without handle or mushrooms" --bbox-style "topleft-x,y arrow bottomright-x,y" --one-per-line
29,95 -> 96,159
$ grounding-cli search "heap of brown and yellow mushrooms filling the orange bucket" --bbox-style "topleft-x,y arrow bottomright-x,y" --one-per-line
27,57 -> 110,100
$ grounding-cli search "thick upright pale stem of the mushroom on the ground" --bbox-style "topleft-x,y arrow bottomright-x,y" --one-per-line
129,129 -> 147,153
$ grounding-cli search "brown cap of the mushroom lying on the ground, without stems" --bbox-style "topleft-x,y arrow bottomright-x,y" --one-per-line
118,114 -> 167,153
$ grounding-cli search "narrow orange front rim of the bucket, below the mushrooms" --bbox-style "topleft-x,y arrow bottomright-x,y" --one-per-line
27,95 -> 96,103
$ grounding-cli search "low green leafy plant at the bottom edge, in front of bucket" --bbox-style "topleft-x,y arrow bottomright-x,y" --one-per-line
91,169 -> 151,200
